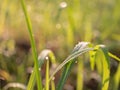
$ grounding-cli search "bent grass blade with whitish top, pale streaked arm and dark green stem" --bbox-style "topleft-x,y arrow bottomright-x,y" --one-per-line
50,42 -> 93,90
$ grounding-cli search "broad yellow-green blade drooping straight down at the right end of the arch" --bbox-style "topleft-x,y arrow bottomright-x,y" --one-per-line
96,45 -> 110,90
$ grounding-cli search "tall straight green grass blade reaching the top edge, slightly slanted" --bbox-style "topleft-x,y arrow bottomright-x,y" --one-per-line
21,0 -> 42,90
